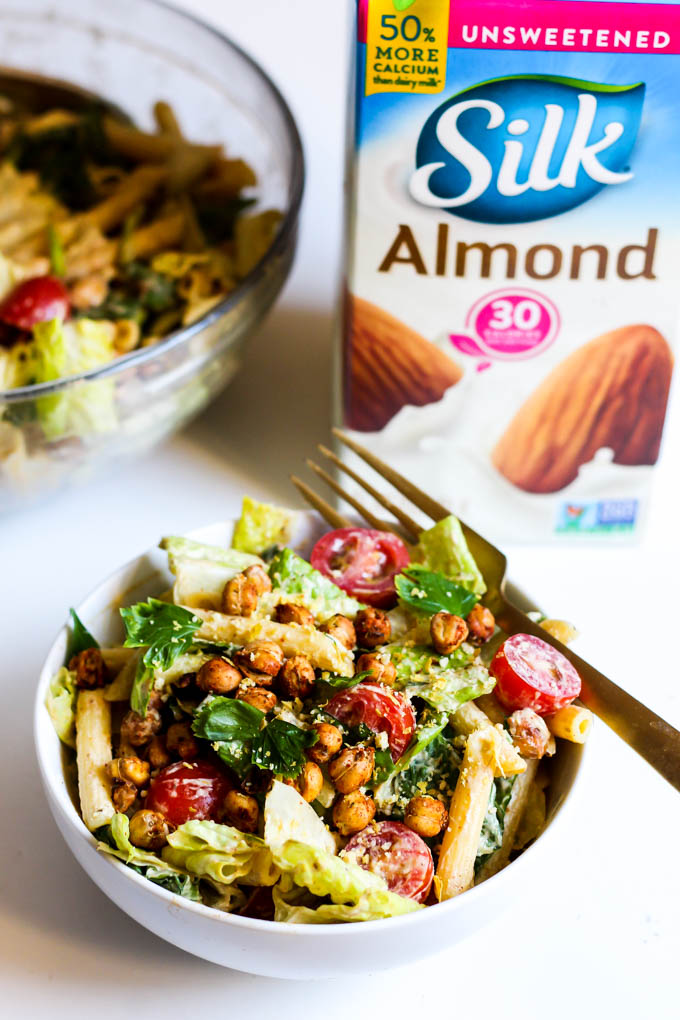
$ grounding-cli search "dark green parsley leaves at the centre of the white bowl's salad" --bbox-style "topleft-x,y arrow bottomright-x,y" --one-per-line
193,698 -> 318,778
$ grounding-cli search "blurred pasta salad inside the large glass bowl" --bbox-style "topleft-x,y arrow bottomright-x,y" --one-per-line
0,96 -> 281,397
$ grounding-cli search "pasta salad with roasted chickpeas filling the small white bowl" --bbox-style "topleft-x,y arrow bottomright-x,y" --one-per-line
47,499 -> 591,924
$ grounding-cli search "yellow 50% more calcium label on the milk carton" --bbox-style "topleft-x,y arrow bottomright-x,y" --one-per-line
365,0 -> 450,96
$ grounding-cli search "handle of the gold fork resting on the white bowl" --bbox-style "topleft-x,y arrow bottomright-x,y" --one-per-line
496,597 -> 680,791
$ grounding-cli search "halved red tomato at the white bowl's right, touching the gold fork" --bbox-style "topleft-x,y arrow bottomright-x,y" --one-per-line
489,634 -> 581,715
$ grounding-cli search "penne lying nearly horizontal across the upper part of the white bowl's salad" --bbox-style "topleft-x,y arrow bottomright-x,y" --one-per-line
191,609 -> 354,676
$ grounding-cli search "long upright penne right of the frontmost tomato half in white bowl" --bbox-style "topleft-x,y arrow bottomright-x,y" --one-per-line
435,726 -> 503,900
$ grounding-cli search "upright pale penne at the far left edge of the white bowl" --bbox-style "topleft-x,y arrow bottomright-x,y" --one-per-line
75,689 -> 115,832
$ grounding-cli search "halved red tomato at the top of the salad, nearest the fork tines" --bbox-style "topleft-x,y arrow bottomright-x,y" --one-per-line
311,527 -> 410,608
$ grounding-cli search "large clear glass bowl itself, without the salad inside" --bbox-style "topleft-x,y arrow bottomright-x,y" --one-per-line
0,0 -> 304,511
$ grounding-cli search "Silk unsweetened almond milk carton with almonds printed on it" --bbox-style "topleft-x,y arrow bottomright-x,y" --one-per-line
343,0 -> 680,542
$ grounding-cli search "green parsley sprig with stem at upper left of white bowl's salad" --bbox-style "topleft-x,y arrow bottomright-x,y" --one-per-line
120,599 -> 201,716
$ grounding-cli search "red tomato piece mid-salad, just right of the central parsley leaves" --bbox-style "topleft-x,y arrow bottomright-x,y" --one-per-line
326,682 -> 416,762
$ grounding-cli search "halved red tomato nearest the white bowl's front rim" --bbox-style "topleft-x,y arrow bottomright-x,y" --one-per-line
343,822 -> 434,903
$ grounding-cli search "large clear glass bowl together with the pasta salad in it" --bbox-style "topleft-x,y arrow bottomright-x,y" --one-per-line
0,0 -> 304,512
